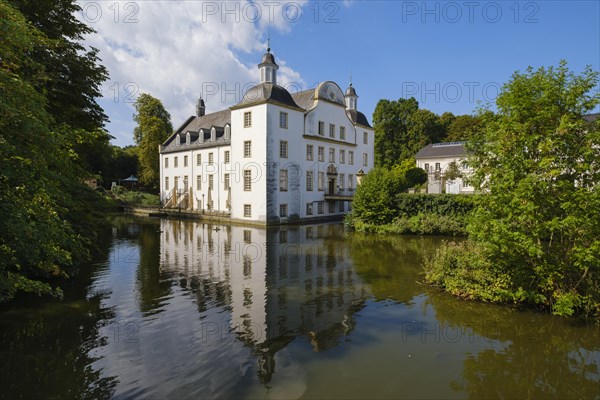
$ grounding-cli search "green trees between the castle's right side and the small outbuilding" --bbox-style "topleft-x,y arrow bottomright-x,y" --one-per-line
373,98 -> 445,168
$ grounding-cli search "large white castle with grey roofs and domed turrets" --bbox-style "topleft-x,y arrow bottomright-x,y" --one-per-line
159,49 -> 374,224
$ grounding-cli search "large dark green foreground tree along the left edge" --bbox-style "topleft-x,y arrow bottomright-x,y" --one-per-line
0,0 -> 110,301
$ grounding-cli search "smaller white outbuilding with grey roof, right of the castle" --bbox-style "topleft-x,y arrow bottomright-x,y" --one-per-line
415,142 -> 474,194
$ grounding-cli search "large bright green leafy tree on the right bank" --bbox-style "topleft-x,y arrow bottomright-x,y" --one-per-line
428,62 -> 600,316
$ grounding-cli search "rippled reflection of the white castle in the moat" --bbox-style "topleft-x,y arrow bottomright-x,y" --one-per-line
161,220 -> 367,382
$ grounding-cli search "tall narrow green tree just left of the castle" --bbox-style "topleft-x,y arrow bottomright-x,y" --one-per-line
133,93 -> 173,187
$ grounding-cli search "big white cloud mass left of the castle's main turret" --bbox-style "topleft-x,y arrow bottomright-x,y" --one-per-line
79,0 -> 307,145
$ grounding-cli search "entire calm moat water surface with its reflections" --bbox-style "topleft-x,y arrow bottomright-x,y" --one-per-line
0,217 -> 600,399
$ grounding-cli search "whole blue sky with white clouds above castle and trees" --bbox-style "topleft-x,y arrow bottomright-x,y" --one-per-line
79,1 -> 600,146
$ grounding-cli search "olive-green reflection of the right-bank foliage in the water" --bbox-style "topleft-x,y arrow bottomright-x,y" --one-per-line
429,291 -> 600,399
